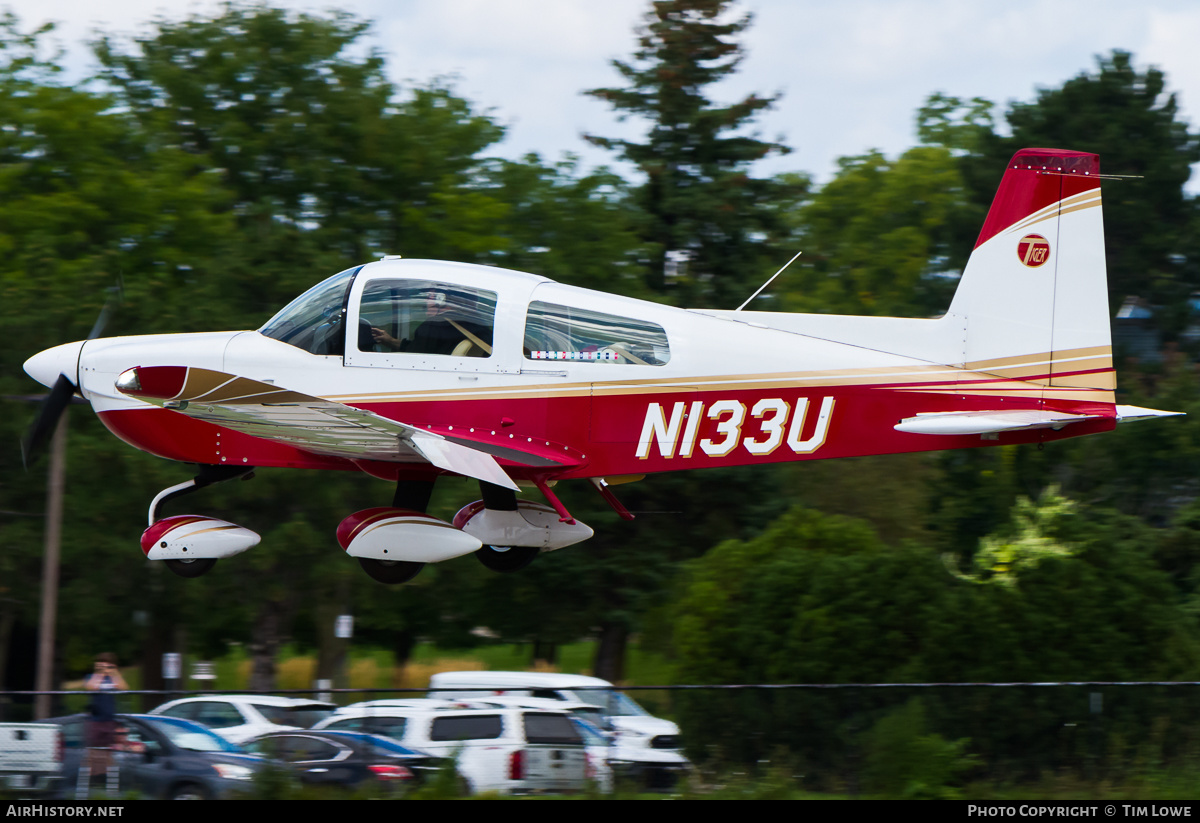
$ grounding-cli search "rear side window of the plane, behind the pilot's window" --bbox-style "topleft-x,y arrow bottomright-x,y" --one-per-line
524,301 -> 671,366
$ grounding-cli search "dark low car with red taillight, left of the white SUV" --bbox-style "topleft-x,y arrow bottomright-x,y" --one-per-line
245,729 -> 444,794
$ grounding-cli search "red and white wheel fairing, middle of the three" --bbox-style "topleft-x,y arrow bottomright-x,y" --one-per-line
337,506 -> 482,563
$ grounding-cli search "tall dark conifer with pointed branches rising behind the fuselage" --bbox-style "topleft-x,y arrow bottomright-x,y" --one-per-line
587,0 -> 808,308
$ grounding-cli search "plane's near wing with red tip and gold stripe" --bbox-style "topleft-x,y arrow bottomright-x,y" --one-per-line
116,366 -> 517,491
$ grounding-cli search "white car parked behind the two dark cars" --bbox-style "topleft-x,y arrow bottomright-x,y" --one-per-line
150,695 -> 337,744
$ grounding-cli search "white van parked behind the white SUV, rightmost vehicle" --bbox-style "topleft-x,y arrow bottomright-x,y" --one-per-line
428,672 -> 679,751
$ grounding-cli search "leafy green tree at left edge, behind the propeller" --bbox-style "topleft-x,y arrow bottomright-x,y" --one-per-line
0,9 -> 241,700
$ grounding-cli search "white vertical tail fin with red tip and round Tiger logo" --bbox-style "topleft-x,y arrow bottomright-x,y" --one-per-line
948,149 -> 1116,403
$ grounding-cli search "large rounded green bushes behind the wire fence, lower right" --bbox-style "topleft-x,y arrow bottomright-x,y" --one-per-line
671,497 -> 1200,779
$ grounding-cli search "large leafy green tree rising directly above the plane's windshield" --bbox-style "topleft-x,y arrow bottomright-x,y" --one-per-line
95,2 -> 506,328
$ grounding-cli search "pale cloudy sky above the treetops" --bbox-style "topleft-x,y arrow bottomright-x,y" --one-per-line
9,0 -> 1200,188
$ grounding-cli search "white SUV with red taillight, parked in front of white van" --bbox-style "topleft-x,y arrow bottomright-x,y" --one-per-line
317,703 -> 589,794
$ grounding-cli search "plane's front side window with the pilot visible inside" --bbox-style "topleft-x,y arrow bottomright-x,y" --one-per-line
358,280 -> 496,358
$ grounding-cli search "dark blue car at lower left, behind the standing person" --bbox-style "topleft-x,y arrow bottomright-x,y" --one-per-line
47,714 -> 263,800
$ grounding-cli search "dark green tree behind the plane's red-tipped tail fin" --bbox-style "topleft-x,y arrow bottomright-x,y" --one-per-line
920,50 -> 1200,335
